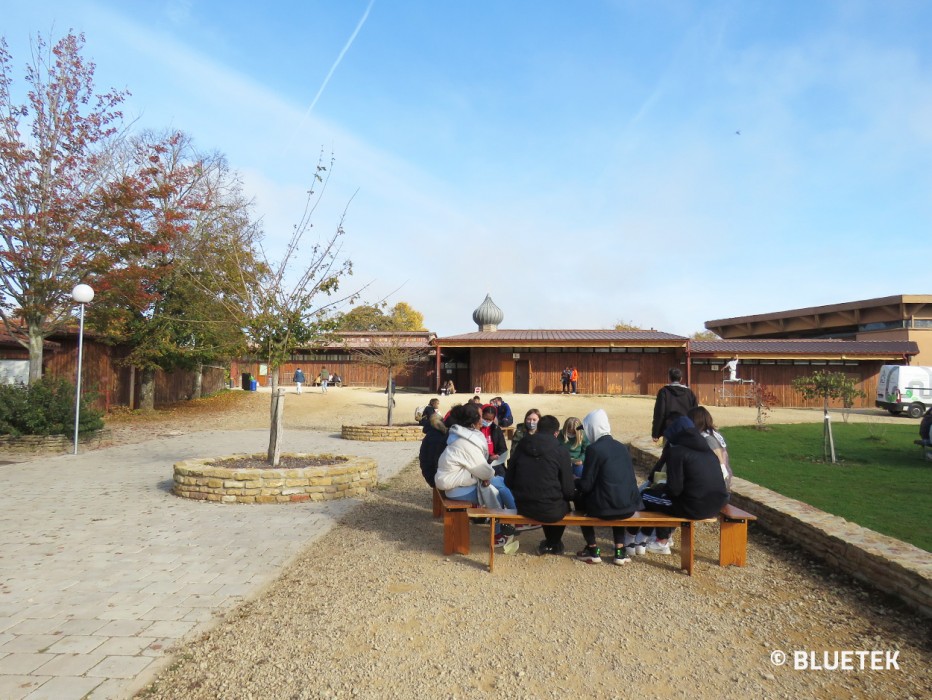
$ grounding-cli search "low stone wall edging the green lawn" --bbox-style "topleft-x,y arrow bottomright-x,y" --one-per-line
628,438 -> 932,617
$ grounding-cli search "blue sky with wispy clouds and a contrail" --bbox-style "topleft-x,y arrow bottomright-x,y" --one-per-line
0,0 -> 932,335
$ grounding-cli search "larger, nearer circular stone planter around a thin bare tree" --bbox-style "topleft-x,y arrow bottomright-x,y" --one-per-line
172,454 -> 378,503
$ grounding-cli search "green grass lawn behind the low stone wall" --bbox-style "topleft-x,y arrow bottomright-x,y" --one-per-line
722,423 -> 932,552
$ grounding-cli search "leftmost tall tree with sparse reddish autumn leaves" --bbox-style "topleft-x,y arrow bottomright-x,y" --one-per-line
0,33 -> 138,383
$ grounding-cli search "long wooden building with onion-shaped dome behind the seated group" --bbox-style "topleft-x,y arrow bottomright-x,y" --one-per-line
434,295 -> 919,407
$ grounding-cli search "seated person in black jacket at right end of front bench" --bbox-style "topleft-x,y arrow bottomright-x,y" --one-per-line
643,416 -> 728,554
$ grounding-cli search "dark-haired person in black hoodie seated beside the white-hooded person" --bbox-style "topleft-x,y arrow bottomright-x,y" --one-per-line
505,416 -> 573,554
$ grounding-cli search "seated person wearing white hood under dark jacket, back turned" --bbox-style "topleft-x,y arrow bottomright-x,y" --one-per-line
575,408 -> 644,565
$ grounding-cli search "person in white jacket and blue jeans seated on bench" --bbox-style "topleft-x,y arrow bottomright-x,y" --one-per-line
434,403 -> 514,545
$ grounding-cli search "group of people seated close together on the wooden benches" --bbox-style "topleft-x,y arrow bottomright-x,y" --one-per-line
419,397 -> 731,565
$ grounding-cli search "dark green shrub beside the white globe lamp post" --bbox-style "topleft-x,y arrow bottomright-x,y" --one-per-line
0,377 -> 104,436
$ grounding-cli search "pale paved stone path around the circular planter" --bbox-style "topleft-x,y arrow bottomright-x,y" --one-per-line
0,430 -> 418,700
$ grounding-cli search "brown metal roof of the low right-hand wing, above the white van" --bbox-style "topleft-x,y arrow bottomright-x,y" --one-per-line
689,340 -> 919,358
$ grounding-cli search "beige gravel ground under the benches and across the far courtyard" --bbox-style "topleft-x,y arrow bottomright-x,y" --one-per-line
107,390 -> 932,700
